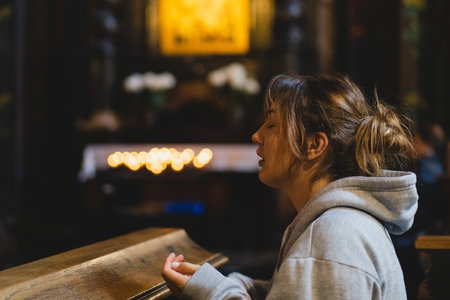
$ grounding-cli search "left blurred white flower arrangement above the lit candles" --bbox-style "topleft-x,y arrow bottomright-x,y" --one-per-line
123,72 -> 177,110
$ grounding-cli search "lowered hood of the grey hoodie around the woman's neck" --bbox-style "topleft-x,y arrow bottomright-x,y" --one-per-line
291,170 -> 419,235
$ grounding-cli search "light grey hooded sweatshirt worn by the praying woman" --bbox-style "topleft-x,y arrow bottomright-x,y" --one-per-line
182,171 -> 418,300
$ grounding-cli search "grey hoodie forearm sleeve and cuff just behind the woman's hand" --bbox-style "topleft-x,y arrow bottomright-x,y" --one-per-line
181,263 -> 268,300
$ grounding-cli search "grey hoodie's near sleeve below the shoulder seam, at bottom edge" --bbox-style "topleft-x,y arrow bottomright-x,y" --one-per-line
267,258 -> 382,300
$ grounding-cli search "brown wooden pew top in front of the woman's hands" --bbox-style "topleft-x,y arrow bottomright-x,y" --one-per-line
0,228 -> 228,300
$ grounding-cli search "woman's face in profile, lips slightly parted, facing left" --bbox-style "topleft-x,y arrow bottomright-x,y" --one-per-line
252,109 -> 293,188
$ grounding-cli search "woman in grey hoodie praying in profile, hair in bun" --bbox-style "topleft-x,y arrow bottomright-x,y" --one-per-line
162,75 -> 417,299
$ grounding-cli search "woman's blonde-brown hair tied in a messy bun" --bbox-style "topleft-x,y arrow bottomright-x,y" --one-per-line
265,74 -> 413,180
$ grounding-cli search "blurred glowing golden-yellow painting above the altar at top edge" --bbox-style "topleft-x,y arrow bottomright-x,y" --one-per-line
158,0 -> 250,55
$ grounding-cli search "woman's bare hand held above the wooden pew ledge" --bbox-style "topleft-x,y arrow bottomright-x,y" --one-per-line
161,253 -> 200,297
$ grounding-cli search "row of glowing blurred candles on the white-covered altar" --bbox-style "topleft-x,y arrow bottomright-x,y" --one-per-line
108,147 -> 213,174
